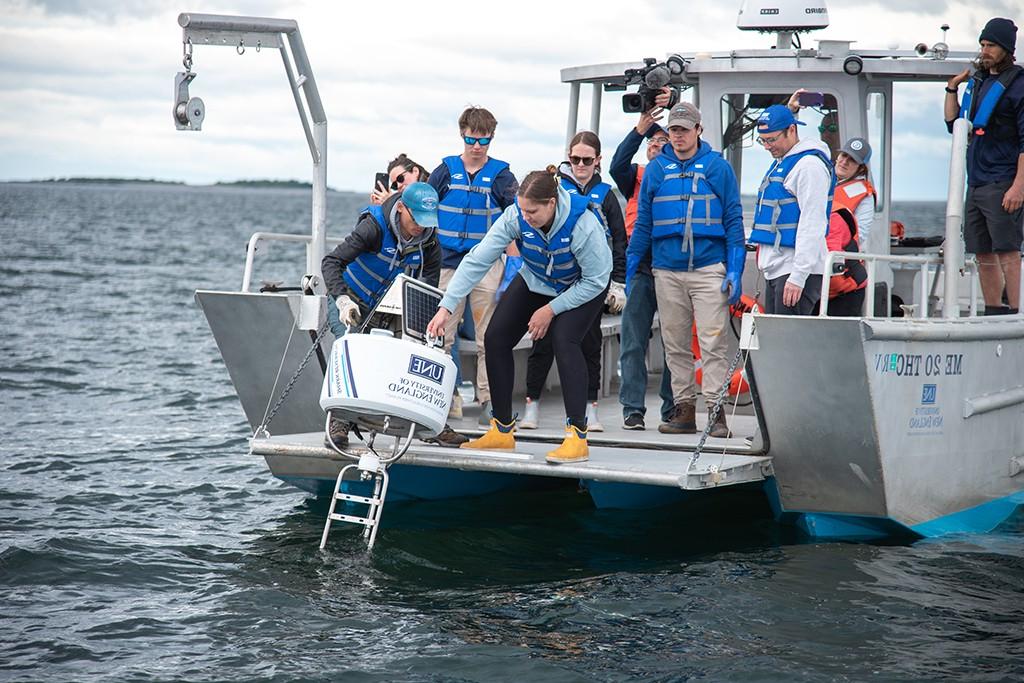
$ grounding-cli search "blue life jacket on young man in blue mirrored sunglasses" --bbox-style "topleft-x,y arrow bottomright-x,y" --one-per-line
437,157 -> 509,254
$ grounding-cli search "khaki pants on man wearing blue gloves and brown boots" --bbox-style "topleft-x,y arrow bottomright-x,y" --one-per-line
654,263 -> 729,404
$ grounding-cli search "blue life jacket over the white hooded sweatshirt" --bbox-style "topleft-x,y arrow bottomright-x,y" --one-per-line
750,150 -> 836,248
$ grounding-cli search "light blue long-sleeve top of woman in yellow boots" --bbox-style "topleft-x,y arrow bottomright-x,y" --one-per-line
440,186 -> 611,315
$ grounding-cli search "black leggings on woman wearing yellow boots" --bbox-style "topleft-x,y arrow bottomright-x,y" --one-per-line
483,275 -> 604,429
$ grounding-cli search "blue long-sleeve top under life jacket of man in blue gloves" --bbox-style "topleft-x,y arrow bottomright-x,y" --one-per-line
626,140 -> 744,282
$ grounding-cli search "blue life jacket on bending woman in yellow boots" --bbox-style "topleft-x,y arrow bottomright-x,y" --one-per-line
516,194 -> 607,294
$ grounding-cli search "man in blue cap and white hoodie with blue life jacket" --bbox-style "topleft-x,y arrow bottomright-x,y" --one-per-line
750,104 -> 836,315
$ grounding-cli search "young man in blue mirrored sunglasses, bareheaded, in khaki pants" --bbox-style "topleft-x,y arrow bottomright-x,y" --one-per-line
430,106 -> 516,424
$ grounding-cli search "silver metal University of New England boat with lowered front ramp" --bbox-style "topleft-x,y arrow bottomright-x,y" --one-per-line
180,1 -> 1024,541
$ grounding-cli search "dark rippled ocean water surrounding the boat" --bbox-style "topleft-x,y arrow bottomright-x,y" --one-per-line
0,184 -> 1024,682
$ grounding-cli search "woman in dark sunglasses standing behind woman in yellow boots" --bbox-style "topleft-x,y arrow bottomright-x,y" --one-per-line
519,130 -> 626,432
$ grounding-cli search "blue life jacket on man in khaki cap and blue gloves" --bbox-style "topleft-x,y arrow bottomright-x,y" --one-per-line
650,156 -> 725,267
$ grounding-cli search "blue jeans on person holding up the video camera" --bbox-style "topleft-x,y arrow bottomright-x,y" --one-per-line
618,271 -> 673,421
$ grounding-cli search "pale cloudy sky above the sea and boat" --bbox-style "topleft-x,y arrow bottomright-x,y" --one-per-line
0,0 -> 1024,200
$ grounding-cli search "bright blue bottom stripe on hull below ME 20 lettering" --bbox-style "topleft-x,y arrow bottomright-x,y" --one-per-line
764,478 -> 1024,541
